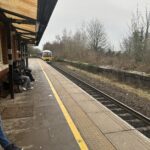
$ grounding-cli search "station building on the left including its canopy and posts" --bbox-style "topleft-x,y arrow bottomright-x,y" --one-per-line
0,0 -> 57,98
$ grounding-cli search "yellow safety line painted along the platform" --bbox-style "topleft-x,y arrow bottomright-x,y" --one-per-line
39,62 -> 88,150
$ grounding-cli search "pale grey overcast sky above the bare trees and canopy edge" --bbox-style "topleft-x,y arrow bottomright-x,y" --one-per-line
39,0 -> 150,49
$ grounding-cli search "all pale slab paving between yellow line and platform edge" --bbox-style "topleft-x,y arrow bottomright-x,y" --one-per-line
40,61 -> 150,150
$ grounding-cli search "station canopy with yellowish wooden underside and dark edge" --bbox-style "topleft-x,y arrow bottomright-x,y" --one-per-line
0,0 -> 57,45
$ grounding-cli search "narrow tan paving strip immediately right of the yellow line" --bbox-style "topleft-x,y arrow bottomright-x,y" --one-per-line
43,60 -> 115,150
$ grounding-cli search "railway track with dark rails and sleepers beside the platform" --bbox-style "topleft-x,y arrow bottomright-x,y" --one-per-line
51,64 -> 150,138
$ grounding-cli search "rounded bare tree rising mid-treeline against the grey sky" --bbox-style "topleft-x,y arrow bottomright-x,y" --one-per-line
87,19 -> 107,51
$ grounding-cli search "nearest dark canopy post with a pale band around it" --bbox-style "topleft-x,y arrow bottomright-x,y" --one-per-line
7,24 -> 14,99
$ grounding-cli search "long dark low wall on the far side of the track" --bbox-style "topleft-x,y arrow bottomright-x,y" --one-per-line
56,60 -> 150,89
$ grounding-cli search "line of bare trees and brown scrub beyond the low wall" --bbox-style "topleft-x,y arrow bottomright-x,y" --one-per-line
43,9 -> 150,72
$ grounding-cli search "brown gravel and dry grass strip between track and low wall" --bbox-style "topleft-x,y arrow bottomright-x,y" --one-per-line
52,63 -> 150,117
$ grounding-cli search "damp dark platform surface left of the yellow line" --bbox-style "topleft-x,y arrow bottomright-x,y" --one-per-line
0,61 -> 79,150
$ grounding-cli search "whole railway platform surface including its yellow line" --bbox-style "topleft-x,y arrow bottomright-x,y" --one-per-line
0,59 -> 150,150
